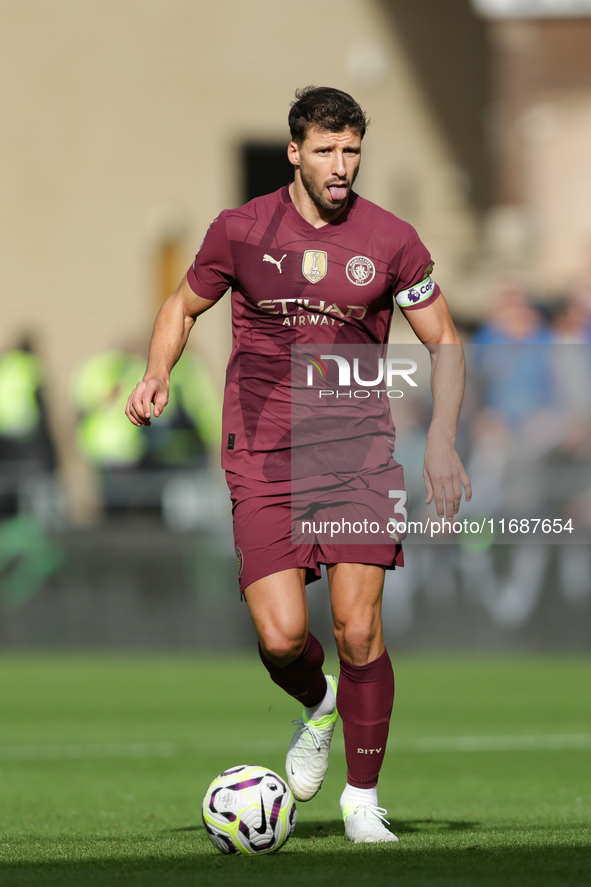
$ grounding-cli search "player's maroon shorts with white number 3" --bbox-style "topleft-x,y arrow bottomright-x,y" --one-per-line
226,460 -> 405,592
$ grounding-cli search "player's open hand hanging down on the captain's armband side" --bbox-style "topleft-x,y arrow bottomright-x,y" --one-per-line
423,434 -> 472,520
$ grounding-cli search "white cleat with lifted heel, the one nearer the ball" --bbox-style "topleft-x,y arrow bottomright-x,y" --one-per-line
285,675 -> 339,801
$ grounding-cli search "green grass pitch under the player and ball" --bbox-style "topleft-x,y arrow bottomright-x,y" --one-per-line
0,654 -> 591,887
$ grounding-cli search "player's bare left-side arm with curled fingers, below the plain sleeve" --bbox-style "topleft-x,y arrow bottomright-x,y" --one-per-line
125,277 -> 215,425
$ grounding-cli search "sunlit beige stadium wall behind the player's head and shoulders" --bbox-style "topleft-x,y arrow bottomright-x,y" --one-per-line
0,0 -> 476,520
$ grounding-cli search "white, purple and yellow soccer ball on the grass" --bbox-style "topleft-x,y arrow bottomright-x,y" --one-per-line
202,764 -> 297,856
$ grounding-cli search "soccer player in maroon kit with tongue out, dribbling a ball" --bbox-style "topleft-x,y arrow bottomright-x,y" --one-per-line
127,87 -> 470,843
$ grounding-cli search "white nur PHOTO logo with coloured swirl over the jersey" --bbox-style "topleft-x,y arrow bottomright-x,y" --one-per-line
302,351 -> 418,400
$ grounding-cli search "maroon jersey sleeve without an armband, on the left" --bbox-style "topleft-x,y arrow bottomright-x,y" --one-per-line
187,212 -> 234,301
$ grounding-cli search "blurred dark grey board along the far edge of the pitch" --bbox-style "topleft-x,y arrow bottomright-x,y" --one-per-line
0,520 -> 591,653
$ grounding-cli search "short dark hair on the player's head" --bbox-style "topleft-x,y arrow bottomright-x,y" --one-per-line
288,86 -> 369,145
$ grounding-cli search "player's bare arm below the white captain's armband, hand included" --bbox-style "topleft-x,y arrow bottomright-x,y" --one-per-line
402,295 -> 472,519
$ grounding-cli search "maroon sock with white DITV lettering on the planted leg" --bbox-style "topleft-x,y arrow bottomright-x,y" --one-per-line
337,650 -> 394,788
